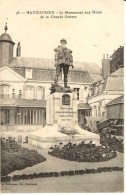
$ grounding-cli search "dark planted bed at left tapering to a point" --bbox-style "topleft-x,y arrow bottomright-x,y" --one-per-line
1,138 -> 46,176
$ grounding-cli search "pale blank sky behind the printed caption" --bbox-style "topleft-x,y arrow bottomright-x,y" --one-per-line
0,0 -> 124,67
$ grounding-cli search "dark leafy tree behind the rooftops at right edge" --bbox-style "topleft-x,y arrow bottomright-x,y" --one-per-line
110,46 -> 124,73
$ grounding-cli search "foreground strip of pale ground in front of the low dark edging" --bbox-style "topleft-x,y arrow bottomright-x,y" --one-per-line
2,171 -> 124,193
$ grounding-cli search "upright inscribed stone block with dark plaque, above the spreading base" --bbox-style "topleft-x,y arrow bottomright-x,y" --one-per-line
46,92 -> 78,125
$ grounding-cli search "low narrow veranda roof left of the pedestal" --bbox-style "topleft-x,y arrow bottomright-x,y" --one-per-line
0,99 -> 46,107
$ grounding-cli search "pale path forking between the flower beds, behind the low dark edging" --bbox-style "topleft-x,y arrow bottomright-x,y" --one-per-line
9,144 -> 124,176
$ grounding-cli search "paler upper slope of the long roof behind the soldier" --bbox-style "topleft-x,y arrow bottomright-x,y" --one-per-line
9,57 -> 101,74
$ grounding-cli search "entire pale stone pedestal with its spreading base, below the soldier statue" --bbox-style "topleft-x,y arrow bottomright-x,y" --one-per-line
28,92 -> 100,148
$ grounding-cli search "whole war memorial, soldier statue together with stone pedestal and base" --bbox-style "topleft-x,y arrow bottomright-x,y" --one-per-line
28,39 -> 100,148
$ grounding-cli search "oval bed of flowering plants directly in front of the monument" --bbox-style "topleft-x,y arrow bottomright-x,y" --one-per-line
48,142 -> 116,162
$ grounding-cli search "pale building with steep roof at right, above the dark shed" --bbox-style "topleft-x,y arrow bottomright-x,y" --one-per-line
87,68 -> 124,117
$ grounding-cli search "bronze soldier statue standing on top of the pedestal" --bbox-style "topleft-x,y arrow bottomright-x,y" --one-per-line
54,39 -> 73,88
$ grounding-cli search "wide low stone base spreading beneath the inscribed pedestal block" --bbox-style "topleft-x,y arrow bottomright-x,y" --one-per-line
28,124 -> 100,148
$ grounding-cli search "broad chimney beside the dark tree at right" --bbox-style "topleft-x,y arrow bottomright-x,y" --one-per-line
102,54 -> 110,78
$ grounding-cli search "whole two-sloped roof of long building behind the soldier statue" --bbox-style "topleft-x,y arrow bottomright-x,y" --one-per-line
9,57 -> 102,83
